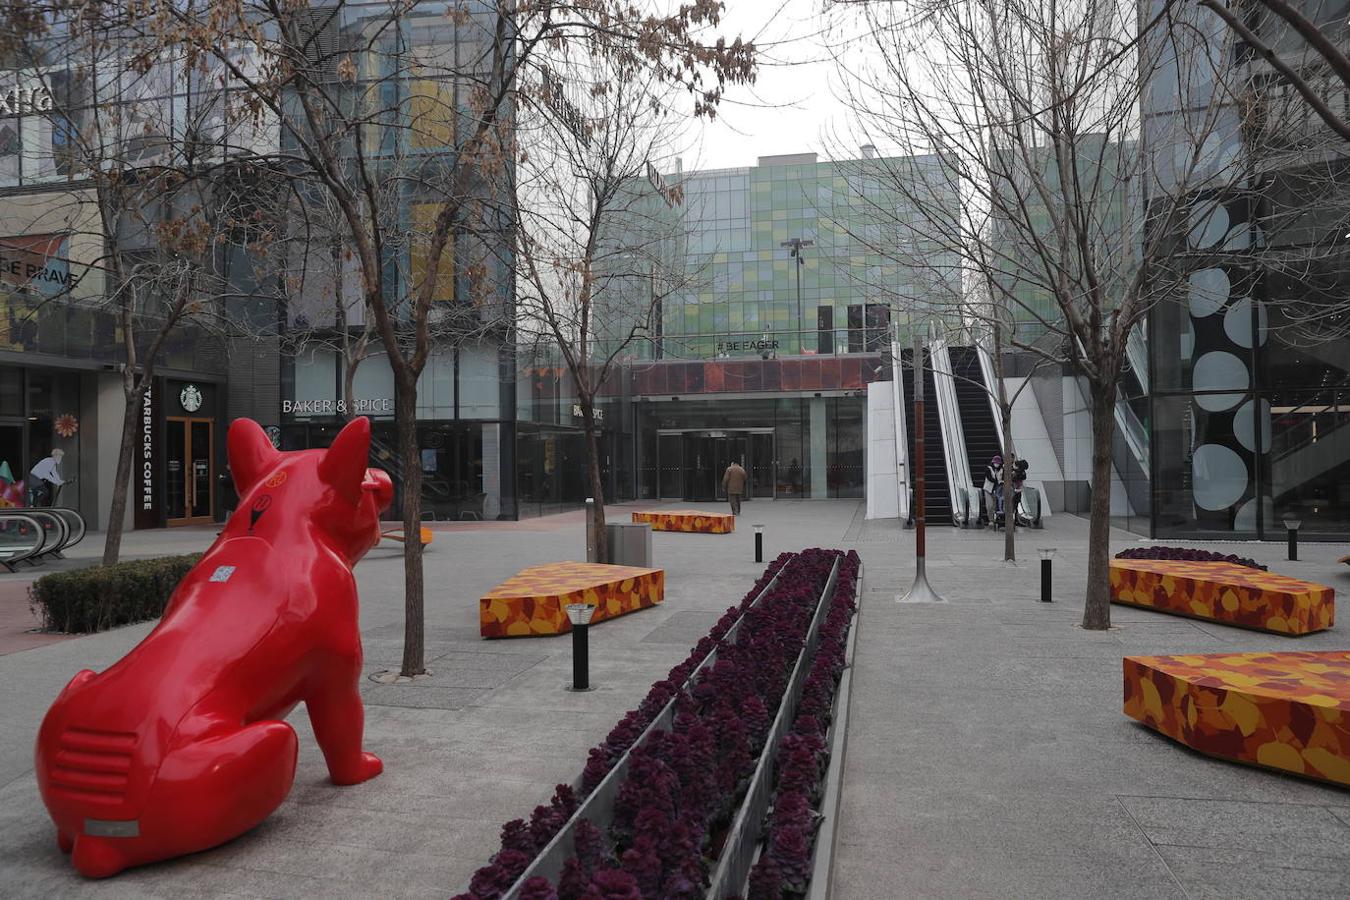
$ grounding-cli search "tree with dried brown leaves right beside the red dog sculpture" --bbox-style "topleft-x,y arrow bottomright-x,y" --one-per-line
146,0 -> 753,676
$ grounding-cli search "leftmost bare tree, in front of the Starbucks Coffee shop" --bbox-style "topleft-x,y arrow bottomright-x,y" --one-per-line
0,4 -> 269,565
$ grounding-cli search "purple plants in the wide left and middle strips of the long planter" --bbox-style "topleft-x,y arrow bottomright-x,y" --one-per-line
456,549 -> 856,900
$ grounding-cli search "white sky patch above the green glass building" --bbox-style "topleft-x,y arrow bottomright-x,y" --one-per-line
682,0 -> 865,171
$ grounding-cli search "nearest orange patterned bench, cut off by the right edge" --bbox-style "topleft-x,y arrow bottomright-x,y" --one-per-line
1125,650 -> 1350,787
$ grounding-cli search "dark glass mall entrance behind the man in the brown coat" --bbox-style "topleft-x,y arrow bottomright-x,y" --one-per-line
656,428 -> 778,502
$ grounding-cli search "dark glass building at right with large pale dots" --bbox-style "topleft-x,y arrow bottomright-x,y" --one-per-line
1138,0 -> 1350,540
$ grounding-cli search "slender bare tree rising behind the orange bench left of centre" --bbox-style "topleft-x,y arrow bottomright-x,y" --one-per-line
514,68 -> 693,563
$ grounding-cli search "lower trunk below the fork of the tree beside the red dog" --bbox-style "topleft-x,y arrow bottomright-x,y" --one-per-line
394,370 -> 427,677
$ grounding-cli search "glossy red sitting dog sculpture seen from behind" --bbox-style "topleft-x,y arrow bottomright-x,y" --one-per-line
36,418 -> 393,878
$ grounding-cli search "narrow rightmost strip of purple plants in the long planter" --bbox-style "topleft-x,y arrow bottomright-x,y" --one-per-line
748,552 -> 859,900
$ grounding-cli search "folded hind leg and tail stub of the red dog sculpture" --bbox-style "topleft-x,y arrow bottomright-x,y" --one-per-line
68,721 -> 298,878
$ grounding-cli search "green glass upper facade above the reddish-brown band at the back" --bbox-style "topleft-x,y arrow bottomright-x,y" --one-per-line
612,154 -> 960,359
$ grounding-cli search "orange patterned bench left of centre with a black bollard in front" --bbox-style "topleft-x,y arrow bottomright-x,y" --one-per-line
478,563 -> 666,637
